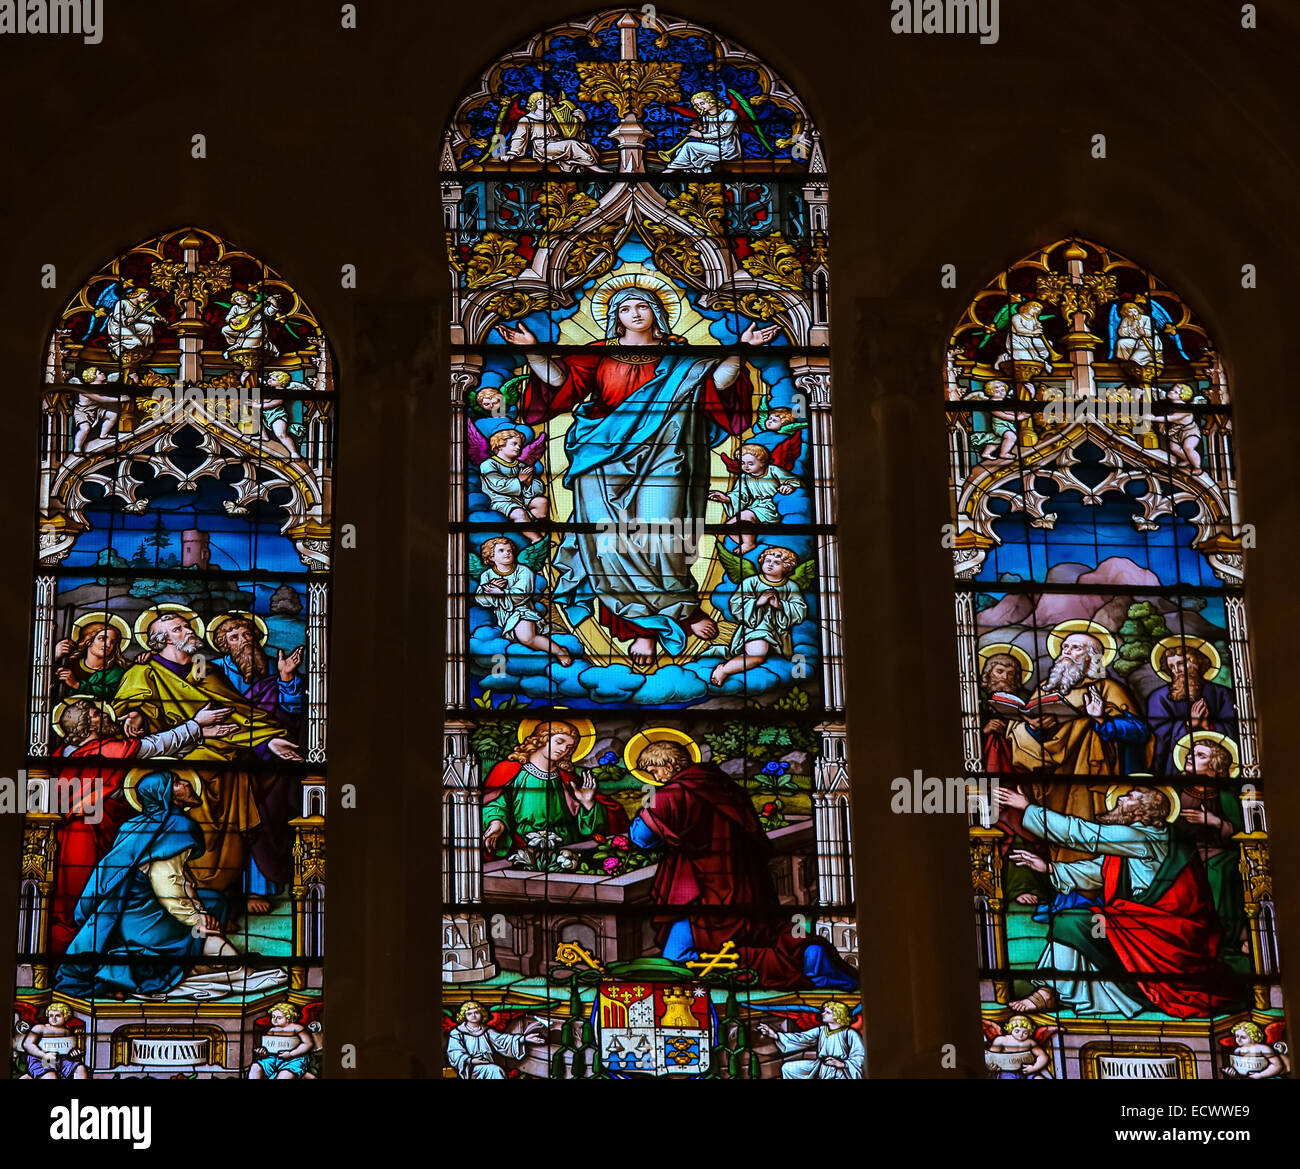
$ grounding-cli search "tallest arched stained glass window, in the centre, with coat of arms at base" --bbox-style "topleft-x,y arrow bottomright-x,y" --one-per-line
442,9 -> 863,1079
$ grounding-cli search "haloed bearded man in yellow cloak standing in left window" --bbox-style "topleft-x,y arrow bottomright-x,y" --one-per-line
113,605 -> 302,893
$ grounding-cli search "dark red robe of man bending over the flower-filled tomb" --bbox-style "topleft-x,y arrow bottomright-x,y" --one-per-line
640,763 -> 805,987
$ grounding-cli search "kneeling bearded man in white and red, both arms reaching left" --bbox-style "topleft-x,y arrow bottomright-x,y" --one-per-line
997,787 -> 1236,1019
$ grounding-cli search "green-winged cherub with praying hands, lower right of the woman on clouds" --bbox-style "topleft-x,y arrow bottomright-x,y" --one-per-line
709,545 -> 816,687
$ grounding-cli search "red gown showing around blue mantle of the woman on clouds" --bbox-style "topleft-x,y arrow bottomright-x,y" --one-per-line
519,341 -> 754,641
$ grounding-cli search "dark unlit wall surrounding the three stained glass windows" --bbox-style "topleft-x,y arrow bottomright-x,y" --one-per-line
0,0 -> 1300,1077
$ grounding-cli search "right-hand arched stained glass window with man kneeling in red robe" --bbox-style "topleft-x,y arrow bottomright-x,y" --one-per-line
945,238 -> 1288,1079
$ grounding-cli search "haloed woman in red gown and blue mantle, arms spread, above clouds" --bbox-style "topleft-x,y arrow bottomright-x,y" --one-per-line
497,273 -> 780,668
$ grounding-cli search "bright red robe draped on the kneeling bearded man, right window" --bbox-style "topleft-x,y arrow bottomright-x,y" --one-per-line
1100,848 -> 1239,1018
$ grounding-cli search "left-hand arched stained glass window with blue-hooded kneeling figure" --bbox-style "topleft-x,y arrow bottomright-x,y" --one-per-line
14,228 -> 334,1078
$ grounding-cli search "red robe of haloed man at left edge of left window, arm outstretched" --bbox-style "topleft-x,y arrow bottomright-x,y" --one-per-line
49,739 -> 140,953
